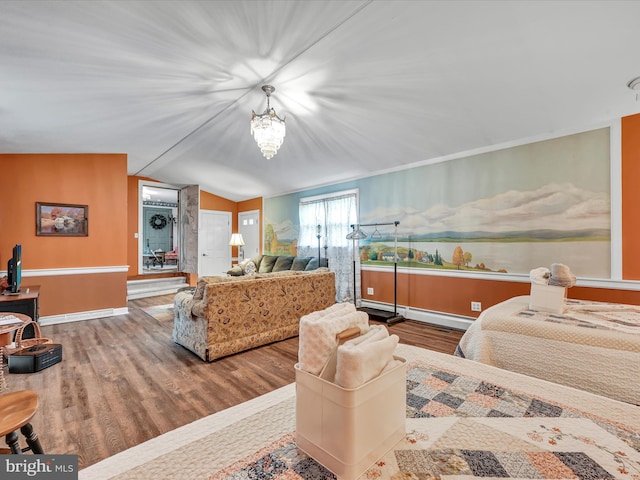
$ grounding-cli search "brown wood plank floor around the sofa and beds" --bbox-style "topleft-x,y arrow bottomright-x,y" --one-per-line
4,295 -> 462,468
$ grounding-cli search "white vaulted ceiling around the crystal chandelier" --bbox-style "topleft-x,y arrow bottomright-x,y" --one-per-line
0,0 -> 640,201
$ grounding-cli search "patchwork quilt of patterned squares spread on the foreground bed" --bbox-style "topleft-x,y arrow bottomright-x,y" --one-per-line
215,346 -> 640,480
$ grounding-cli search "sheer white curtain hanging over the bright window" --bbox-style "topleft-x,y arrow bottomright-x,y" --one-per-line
298,192 -> 360,302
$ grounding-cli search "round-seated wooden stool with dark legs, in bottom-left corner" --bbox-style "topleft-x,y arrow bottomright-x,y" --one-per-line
0,390 -> 44,454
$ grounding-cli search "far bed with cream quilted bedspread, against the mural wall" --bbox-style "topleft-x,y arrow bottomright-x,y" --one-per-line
456,295 -> 640,405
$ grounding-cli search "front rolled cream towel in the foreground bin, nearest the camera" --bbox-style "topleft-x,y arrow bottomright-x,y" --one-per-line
335,325 -> 399,388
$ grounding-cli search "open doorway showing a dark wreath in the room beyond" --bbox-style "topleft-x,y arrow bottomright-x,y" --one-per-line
138,181 -> 180,275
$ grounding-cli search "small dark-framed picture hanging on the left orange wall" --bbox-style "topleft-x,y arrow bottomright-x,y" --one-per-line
36,202 -> 89,237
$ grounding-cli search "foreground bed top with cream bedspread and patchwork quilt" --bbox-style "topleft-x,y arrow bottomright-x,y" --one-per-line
79,345 -> 640,480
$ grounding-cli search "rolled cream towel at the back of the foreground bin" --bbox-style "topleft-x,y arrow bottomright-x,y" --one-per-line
298,302 -> 369,375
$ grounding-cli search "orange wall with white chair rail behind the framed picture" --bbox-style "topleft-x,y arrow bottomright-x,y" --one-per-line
0,154 -> 127,316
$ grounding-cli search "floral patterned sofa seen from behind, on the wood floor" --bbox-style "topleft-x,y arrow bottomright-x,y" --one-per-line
173,268 -> 336,361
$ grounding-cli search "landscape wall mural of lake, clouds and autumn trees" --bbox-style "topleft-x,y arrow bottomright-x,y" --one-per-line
265,128 -> 611,278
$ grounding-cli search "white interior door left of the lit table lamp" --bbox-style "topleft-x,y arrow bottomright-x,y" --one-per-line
198,210 -> 231,276
